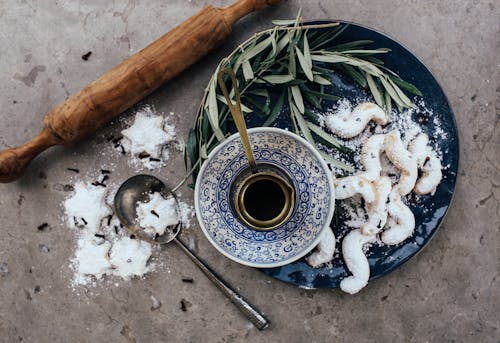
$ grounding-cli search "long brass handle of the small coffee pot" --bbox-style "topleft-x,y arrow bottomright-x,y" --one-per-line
217,68 -> 257,171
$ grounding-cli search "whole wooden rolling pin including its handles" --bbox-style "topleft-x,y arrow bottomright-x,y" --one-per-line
0,0 -> 282,183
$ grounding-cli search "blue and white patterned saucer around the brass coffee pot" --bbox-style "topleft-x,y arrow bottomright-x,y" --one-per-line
194,128 -> 335,268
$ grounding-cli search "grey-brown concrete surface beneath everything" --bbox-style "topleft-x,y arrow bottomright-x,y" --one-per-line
0,0 -> 500,343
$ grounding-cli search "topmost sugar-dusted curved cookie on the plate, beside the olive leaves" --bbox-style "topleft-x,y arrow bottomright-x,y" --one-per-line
325,102 -> 389,138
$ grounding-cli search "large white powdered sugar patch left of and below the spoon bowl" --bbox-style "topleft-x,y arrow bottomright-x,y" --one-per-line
63,182 -> 194,286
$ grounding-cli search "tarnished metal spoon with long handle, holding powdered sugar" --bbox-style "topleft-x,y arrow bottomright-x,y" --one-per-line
114,175 -> 269,330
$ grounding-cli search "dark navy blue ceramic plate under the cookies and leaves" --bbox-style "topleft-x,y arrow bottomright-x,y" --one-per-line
256,21 -> 459,288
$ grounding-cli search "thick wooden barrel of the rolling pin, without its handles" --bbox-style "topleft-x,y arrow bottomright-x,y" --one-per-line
44,6 -> 231,145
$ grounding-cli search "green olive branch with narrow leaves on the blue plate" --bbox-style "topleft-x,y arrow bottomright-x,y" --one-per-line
174,11 -> 422,194
